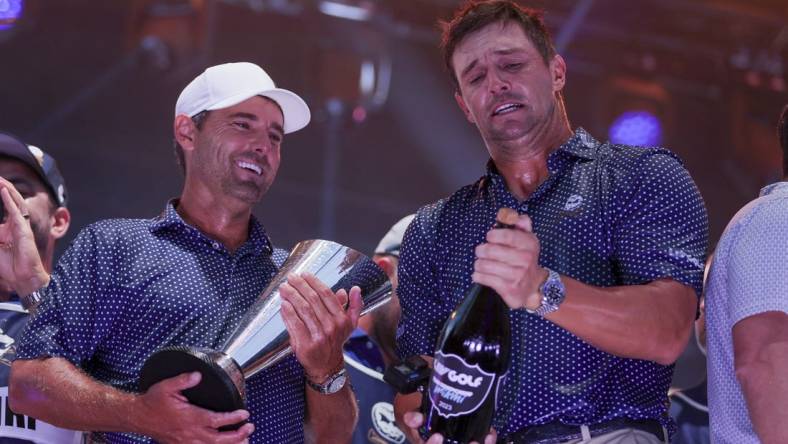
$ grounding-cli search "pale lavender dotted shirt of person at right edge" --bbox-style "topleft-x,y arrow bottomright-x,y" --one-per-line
706,182 -> 788,444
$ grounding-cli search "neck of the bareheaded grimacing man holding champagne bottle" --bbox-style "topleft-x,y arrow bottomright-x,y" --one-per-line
487,112 -> 573,201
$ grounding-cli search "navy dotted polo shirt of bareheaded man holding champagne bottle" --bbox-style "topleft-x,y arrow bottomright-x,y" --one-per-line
397,129 -> 708,435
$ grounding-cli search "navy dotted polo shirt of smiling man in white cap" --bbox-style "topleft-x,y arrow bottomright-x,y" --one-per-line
18,203 -> 305,443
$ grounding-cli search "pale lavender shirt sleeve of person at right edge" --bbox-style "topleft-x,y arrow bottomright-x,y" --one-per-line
726,198 -> 788,324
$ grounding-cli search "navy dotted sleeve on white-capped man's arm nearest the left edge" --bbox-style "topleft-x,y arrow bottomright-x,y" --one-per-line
17,226 -> 118,366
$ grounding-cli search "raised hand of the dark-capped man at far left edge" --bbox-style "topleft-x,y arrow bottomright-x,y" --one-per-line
0,177 -> 49,295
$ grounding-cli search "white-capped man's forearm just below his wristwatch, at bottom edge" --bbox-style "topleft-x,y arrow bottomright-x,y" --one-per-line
305,383 -> 358,443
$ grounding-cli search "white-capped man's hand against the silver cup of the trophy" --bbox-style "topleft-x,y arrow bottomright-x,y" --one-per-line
279,273 -> 362,383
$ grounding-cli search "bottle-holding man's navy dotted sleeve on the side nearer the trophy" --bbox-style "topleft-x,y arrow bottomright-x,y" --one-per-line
397,206 -> 451,358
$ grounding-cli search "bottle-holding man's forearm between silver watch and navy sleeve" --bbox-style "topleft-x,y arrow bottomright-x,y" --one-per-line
546,276 -> 697,365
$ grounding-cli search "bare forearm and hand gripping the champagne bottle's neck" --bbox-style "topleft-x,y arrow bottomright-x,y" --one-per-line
473,216 -> 697,365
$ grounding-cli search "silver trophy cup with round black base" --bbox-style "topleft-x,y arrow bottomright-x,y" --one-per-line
140,240 -> 391,420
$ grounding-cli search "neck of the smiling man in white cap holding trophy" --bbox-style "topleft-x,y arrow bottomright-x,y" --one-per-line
177,187 -> 252,253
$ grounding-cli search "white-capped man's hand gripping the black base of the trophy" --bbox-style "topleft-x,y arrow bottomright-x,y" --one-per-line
135,372 -> 254,444
